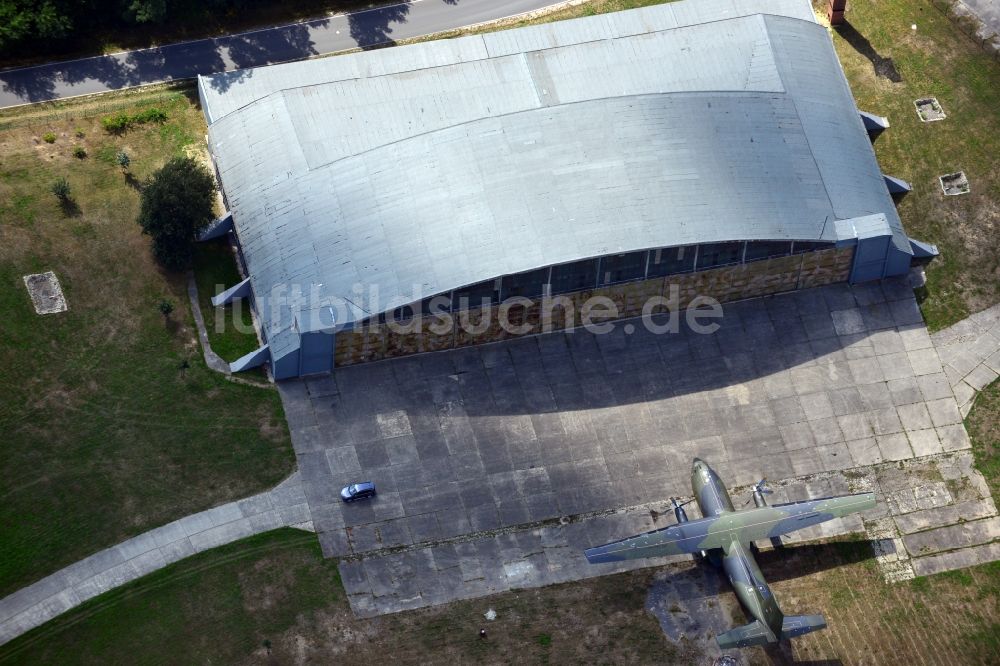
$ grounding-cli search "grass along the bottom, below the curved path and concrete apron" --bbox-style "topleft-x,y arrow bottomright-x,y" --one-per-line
0,529 -> 1000,664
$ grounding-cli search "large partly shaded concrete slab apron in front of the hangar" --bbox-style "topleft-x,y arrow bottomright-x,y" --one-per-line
272,282 -> 1000,614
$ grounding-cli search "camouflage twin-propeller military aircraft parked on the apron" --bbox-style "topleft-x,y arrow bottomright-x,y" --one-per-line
585,458 -> 875,649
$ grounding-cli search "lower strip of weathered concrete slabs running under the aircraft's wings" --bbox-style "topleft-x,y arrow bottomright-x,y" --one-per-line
341,451 -> 1000,616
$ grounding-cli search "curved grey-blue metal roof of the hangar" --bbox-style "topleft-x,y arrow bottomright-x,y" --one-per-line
199,0 -> 908,338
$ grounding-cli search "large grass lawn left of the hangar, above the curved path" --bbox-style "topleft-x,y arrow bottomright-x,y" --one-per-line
0,87 -> 294,597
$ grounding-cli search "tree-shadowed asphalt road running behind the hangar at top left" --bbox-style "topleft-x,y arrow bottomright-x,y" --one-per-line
0,0 -> 556,108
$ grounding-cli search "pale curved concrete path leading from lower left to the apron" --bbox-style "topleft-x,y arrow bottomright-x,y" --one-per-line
0,472 -> 312,645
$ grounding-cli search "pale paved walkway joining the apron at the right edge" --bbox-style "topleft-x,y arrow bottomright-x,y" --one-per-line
931,305 -> 1000,416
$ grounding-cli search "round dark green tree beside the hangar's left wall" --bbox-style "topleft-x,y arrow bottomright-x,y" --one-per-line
138,157 -> 215,271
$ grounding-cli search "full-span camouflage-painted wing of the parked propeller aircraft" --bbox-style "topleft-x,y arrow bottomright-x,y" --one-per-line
584,493 -> 875,564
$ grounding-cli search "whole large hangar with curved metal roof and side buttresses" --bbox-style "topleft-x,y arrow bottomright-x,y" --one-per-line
199,0 -> 934,379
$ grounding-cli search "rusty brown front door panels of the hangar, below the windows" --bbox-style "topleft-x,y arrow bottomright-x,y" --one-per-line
333,246 -> 855,367
